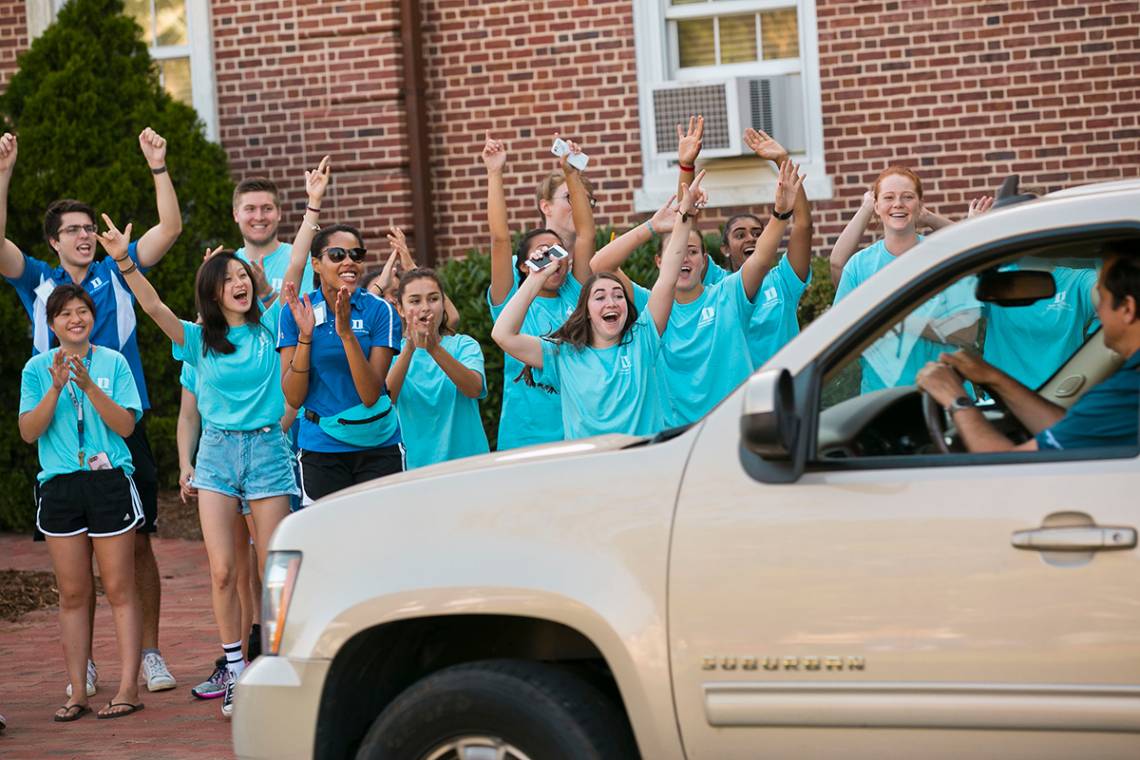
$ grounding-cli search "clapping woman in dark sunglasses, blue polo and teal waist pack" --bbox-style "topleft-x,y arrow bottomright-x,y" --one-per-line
277,216 -> 404,505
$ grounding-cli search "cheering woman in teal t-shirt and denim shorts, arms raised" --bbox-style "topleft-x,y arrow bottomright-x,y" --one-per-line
99,165 -> 316,717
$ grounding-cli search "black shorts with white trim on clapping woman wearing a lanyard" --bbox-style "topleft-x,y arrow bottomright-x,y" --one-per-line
35,467 -> 143,538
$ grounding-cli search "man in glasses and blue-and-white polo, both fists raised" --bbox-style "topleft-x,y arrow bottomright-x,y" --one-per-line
0,128 -> 182,692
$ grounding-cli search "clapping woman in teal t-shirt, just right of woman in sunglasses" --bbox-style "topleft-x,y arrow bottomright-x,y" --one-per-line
388,269 -> 489,469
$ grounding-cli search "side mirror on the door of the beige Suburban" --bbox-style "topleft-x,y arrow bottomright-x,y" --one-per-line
740,369 -> 799,459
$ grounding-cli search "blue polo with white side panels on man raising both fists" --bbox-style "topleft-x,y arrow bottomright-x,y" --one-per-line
5,240 -> 150,409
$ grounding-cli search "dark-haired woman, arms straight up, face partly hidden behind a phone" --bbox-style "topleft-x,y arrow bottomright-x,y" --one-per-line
482,133 -> 594,451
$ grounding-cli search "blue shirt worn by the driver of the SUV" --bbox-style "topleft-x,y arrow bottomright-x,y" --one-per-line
1036,351 -> 1140,450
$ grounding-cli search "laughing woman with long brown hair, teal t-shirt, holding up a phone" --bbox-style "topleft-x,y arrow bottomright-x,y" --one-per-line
491,172 -> 706,439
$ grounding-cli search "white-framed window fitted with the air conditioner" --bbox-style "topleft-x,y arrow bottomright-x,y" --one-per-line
634,0 -> 832,211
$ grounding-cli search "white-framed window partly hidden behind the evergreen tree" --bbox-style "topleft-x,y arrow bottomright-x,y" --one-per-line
123,0 -> 218,140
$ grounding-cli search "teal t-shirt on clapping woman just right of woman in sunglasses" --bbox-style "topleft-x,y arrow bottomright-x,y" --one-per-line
396,335 -> 490,469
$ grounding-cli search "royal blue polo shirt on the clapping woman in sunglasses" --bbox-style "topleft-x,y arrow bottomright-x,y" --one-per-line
277,288 -> 402,453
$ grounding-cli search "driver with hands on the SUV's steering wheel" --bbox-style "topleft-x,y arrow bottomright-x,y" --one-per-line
918,250 -> 1140,451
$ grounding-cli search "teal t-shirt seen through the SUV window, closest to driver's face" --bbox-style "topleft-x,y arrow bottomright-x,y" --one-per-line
982,267 -> 1098,389
